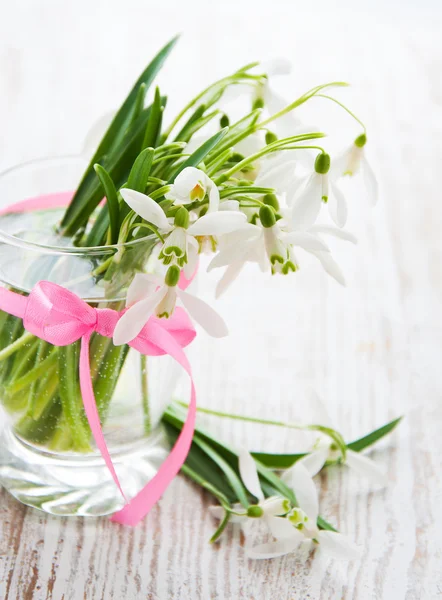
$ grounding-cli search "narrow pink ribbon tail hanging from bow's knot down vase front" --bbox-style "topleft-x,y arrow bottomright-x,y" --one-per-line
80,333 -> 127,503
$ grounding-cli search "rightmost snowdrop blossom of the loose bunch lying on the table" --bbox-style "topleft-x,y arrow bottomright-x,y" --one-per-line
294,390 -> 387,486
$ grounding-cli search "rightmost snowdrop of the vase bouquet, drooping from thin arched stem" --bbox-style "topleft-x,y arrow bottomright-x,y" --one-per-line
333,133 -> 378,206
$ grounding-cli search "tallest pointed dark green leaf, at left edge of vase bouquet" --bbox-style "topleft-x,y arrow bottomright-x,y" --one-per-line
61,37 -> 178,235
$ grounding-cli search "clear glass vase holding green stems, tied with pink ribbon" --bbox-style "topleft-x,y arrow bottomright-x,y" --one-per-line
0,157 -> 179,516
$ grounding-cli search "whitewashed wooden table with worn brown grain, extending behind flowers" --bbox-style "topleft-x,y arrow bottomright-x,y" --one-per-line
0,0 -> 442,600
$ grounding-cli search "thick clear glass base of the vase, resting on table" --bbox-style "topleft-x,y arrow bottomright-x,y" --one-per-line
0,427 -> 168,517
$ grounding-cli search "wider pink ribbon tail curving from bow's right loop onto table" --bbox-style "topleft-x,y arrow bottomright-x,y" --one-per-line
111,323 -> 196,527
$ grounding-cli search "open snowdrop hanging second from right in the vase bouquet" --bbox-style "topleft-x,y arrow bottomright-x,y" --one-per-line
288,153 -> 347,228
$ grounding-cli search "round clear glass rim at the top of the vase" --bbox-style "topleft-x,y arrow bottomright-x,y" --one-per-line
0,154 -> 156,256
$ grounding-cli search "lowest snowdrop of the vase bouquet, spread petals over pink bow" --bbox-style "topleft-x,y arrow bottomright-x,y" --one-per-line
113,265 -> 228,346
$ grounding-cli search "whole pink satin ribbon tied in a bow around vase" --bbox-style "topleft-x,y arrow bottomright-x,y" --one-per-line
0,193 -> 196,526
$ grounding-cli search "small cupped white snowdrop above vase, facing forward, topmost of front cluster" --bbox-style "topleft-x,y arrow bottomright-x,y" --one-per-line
165,167 -> 219,212
